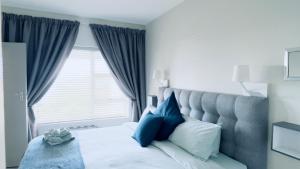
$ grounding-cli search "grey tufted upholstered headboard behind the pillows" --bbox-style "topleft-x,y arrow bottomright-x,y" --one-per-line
158,88 -> 268,169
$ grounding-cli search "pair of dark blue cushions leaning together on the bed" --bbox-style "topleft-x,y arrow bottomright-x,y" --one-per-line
133,93 -> 185,147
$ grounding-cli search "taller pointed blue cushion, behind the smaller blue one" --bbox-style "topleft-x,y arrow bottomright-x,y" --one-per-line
154,92 -> 184,141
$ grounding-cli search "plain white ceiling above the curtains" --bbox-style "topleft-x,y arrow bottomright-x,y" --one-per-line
2,0 -> 184,25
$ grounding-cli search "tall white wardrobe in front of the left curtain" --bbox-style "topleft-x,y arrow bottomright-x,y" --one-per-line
2,43 -> 28,167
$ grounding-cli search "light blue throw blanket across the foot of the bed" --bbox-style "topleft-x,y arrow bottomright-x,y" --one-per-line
19,136 -> 85,169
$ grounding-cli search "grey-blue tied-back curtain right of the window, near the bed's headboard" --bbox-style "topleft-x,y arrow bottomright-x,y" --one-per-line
90,24 -> 146,121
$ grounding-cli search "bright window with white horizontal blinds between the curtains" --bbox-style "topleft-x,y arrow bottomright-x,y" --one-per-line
34,48 -> 129,123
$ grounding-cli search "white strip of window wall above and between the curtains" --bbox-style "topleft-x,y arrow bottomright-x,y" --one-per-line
2,6 -> 145,48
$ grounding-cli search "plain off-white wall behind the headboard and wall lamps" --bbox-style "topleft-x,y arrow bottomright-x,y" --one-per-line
146,0 -> 300,169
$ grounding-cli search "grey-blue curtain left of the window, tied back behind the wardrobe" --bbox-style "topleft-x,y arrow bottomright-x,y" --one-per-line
2,13 -> 79,139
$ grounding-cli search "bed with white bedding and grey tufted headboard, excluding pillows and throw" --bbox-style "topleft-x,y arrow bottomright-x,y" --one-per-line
21,88 -> 268,169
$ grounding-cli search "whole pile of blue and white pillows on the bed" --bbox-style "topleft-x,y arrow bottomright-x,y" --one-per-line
133,93 -> 221,161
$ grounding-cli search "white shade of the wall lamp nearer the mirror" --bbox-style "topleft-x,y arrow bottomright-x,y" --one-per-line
232,65 -> 250,82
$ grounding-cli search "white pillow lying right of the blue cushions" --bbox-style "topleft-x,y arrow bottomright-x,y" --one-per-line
169,120 -> 221,160
